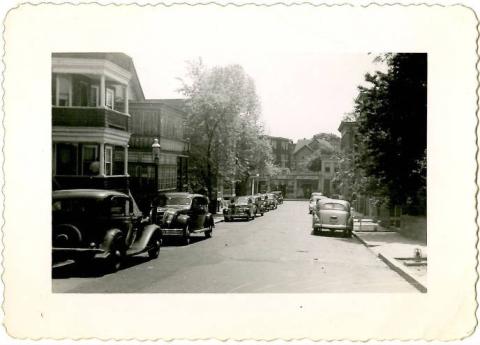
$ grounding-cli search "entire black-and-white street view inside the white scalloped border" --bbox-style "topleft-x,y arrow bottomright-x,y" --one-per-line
52,52 -> 428,293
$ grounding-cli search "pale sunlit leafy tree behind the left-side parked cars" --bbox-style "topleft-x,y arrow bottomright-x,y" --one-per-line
180,61 -> 278,198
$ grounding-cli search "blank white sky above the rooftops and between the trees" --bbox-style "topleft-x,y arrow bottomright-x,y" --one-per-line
130,53 -> 384,141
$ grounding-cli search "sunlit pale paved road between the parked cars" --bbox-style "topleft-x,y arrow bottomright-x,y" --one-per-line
53,201 -> 417,293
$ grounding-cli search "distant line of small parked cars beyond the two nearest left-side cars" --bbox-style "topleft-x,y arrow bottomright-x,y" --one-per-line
223,191 -> 283,222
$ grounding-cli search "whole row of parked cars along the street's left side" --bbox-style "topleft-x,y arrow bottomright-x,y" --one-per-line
52,189 -> 283,272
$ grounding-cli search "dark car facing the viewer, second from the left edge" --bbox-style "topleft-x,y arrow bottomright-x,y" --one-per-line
152,193 -> 215,245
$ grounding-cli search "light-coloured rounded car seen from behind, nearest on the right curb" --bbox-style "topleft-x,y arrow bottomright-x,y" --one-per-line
312,198 -> 353,237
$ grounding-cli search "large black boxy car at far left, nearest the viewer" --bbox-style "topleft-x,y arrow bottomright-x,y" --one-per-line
52,189 -> 162,272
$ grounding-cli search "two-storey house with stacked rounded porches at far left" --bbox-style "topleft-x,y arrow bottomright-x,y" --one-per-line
52,53 -> 145,191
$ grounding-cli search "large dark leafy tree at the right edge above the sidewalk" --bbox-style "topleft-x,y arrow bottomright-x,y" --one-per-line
355,54 -> 427,213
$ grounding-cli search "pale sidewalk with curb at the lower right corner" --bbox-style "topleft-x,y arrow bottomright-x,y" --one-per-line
354,231 -> 427,292
